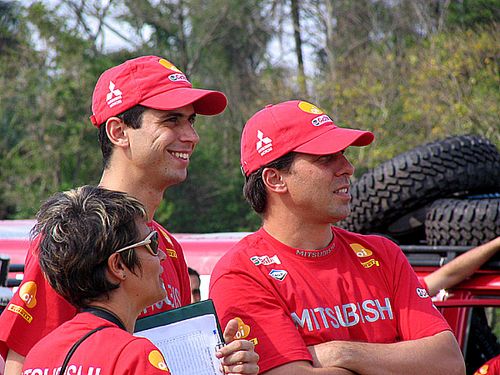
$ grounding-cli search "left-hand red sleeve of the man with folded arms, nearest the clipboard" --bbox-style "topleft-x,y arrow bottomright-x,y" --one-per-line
210,267 -> 312,372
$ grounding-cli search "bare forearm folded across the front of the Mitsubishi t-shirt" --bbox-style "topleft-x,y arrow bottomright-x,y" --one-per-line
309,331 -> 465,375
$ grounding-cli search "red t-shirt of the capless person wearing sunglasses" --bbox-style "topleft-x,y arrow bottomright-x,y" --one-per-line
22,312 -> 170,375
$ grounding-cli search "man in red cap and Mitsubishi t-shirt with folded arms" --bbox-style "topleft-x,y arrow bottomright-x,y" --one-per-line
210,100 -> 465,375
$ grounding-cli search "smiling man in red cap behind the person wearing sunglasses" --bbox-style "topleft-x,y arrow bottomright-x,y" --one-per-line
0,56 -> 258,375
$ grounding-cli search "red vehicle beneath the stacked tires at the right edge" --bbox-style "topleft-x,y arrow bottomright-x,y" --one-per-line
402,246 -> 500,375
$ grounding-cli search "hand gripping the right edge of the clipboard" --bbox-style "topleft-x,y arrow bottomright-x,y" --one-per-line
215,319 -> 259,375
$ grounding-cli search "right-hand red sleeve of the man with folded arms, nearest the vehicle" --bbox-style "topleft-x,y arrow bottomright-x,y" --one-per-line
385,241 -> 451,341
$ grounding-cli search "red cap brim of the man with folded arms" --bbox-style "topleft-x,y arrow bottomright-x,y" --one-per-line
293,127 -> 375,155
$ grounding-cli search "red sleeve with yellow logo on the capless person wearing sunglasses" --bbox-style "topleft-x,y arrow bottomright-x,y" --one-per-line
112,338 -> 170,375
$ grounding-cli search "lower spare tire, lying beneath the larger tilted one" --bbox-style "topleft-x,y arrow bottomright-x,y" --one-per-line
425,197 -> 500,246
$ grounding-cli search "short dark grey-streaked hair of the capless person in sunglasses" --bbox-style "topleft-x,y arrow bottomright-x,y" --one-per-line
31,186 -> 147,307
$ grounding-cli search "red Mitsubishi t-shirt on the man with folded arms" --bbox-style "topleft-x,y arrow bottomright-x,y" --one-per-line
210,227 -> 450,372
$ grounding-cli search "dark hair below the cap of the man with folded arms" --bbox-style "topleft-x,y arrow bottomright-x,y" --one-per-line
243,152 -> 297,214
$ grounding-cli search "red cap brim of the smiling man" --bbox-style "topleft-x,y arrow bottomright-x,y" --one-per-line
139,87 -> 227,115
